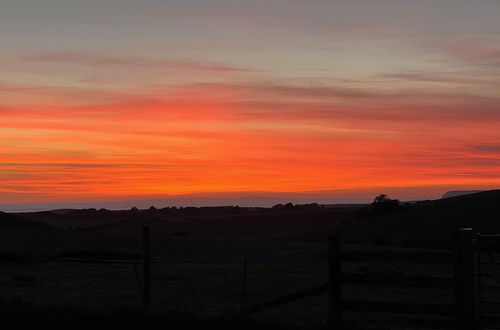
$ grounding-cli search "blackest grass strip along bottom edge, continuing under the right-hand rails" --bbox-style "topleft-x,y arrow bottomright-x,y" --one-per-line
0,300 -> 449,330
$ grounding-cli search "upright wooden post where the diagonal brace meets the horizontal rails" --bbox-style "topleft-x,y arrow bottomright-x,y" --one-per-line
328,235 -> 342,330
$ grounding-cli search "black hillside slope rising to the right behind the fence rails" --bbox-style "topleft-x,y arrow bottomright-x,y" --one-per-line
337,190 -> 500,247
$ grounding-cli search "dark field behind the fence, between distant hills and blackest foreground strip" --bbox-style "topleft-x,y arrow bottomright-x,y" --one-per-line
0,244 -> 453,329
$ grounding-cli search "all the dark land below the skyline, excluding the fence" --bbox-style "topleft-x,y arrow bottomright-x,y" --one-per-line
0,191 -> 500,330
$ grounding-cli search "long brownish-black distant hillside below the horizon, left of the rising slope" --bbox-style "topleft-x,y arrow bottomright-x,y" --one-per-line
15,204 -> 361,241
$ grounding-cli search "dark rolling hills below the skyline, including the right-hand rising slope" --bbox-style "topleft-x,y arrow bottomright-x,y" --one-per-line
10,190 -> 500,247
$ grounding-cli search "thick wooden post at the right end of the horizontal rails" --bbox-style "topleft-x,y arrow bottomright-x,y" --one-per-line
455,228 -> 479,330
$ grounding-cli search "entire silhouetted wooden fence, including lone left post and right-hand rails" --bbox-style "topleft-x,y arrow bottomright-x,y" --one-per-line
42,227 -> 500,330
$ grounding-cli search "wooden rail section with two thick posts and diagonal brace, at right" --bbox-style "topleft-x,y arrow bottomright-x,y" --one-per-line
242,228 -> 490,330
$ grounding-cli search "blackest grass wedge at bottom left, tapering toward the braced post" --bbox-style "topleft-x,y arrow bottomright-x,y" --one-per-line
0,300 -> 320,330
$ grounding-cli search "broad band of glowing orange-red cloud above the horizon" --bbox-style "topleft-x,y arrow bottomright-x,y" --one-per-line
0,78 -> 500,202
